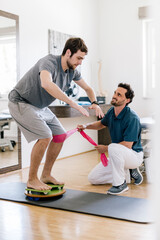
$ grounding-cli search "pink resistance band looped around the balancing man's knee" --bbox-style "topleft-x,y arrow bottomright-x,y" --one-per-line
52,128 -> 108,167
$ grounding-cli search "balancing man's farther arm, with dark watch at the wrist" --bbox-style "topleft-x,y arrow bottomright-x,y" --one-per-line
75,79 -> 104,118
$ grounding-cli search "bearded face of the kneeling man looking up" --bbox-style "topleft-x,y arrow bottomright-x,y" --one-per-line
111,87 -> 130,107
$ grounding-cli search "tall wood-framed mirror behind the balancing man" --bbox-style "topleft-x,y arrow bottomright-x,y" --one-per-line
0,10 -> 21,174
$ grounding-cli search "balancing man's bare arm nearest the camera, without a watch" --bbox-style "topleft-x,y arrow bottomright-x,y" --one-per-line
40,70 -> 89,117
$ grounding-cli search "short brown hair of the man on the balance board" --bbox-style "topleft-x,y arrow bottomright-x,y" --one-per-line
62,38 -> 88,57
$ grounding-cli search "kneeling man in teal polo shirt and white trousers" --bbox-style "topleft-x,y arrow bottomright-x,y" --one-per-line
78,83 -> 143,194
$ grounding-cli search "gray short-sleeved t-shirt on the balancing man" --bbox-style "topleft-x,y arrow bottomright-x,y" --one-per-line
8,54 -> 82,108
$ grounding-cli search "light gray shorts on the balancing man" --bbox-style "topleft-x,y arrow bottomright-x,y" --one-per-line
8,101 -> 66,142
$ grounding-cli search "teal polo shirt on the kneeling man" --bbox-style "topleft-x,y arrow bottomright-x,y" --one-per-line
101,106 -> 143,152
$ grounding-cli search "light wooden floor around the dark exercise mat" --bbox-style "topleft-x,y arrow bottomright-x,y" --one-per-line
0,151 -> 154,240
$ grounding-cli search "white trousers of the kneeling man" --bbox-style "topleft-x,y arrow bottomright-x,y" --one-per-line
88,143 -> 143,186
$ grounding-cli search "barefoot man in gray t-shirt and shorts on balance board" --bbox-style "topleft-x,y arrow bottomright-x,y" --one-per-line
8,38 -> 104,190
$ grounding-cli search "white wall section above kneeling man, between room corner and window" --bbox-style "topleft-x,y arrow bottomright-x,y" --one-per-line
99,0 -> 153,117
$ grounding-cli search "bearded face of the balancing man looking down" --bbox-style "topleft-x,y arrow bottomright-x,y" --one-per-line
67,49 -> 86,70
